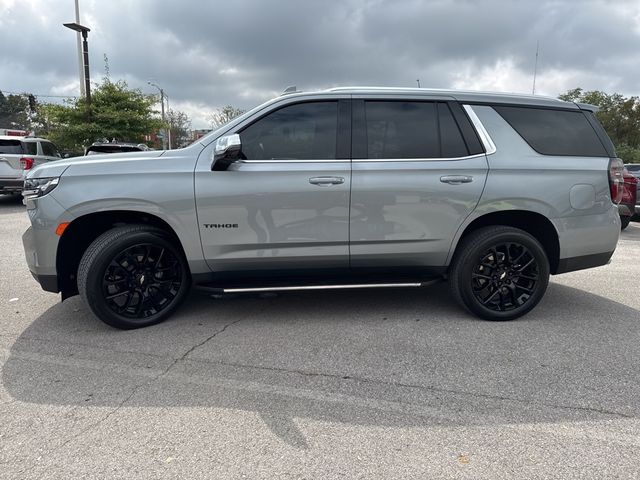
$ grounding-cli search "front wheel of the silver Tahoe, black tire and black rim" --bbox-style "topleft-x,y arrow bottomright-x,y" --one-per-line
78,225 -> 191,330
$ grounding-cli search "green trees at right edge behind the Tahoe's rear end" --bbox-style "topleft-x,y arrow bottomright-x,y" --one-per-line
559,88 -> 640,163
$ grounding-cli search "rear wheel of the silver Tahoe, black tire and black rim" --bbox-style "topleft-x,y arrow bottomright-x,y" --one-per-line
449,226 -> 549,321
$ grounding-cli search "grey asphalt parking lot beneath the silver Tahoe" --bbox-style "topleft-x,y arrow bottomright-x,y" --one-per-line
0,192 -> 640,479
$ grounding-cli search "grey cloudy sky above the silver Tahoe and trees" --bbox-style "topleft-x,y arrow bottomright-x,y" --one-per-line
0,0 -> 640,128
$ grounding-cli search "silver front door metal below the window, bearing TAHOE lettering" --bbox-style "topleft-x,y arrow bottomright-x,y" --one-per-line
196,161 -> 351,271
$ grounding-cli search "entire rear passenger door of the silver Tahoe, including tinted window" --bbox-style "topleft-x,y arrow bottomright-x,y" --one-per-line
350,98 -> 487,267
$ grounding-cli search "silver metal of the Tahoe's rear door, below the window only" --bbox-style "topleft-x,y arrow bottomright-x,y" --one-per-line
351,159 -> 487,267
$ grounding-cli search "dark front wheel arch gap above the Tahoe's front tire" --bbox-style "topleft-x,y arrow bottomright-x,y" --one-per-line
56,210 -> 186,300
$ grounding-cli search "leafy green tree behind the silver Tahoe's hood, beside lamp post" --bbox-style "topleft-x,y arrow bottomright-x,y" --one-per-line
38,77 -> 162,150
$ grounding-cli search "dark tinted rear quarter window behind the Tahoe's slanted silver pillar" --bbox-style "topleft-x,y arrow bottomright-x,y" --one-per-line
493,106 -> 609,157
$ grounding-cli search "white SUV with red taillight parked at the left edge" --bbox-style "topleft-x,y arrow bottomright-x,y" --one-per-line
0,134 -> 61,193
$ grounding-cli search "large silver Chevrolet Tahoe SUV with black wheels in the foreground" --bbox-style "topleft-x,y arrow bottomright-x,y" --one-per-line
23,88 -> 622,328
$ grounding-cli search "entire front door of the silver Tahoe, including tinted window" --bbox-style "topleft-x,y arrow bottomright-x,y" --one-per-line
195,101 -> 351,272
